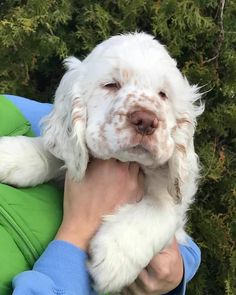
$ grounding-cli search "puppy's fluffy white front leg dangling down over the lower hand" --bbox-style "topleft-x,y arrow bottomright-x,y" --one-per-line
88,200 -> 179,292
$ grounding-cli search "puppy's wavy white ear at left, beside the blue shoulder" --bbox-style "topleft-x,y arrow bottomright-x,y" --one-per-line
42,57 -> 88,180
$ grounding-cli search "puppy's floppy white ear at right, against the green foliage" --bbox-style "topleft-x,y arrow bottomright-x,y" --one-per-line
168,81 -> 204,203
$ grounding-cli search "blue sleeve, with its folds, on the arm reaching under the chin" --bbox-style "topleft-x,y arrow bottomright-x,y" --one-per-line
13,240 -> 96,295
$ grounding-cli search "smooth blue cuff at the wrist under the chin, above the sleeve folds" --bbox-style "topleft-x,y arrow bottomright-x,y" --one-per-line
33,240 -> 95,295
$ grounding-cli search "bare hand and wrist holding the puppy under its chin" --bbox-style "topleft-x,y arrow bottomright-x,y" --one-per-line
56,159 -> 144,250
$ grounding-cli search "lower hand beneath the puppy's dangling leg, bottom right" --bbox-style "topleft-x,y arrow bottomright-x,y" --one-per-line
122,239 -> 183,295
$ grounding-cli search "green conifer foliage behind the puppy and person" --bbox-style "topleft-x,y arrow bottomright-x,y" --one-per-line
0,0 -> 236,295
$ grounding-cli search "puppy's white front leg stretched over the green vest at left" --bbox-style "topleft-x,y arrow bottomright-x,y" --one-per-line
0,136 -> 61,187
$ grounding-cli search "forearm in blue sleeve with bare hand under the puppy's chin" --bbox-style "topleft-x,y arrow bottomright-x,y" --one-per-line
13,159 -> 143,295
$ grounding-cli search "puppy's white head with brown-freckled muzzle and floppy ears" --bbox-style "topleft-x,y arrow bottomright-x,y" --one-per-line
44,33 -> 201,202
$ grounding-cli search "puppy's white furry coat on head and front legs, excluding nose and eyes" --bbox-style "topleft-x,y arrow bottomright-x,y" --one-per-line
0,33 -> 203,292
